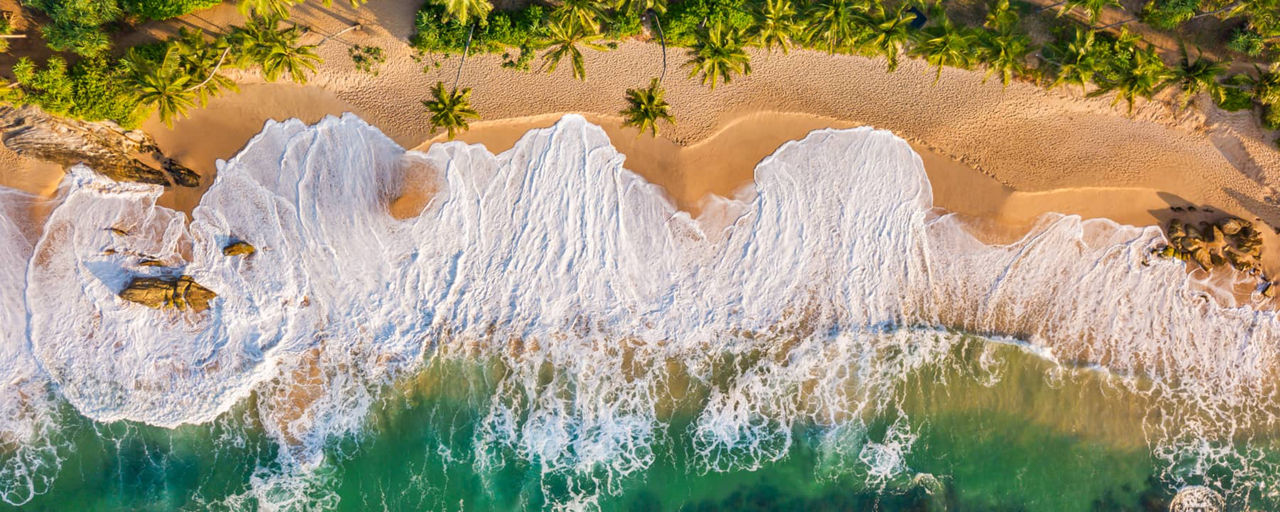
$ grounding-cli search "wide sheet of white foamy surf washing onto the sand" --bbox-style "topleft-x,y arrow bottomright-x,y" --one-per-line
0,115 -> 1280,506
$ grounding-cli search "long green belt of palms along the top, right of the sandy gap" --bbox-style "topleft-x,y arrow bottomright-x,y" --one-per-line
412,0 -> 1280,135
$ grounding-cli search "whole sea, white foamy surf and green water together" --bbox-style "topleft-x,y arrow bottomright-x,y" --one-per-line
0,115 -> 1280,511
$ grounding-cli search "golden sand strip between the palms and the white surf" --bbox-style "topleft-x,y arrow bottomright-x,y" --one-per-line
0,0 -> 1280,274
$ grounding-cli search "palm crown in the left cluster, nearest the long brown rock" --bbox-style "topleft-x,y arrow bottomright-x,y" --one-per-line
125,47 -> 196,128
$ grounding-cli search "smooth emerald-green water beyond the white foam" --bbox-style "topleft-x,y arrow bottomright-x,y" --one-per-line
5,343 -> 1280,511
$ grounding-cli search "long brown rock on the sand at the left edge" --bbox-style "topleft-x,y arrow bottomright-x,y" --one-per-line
0,105 -> 200,187
